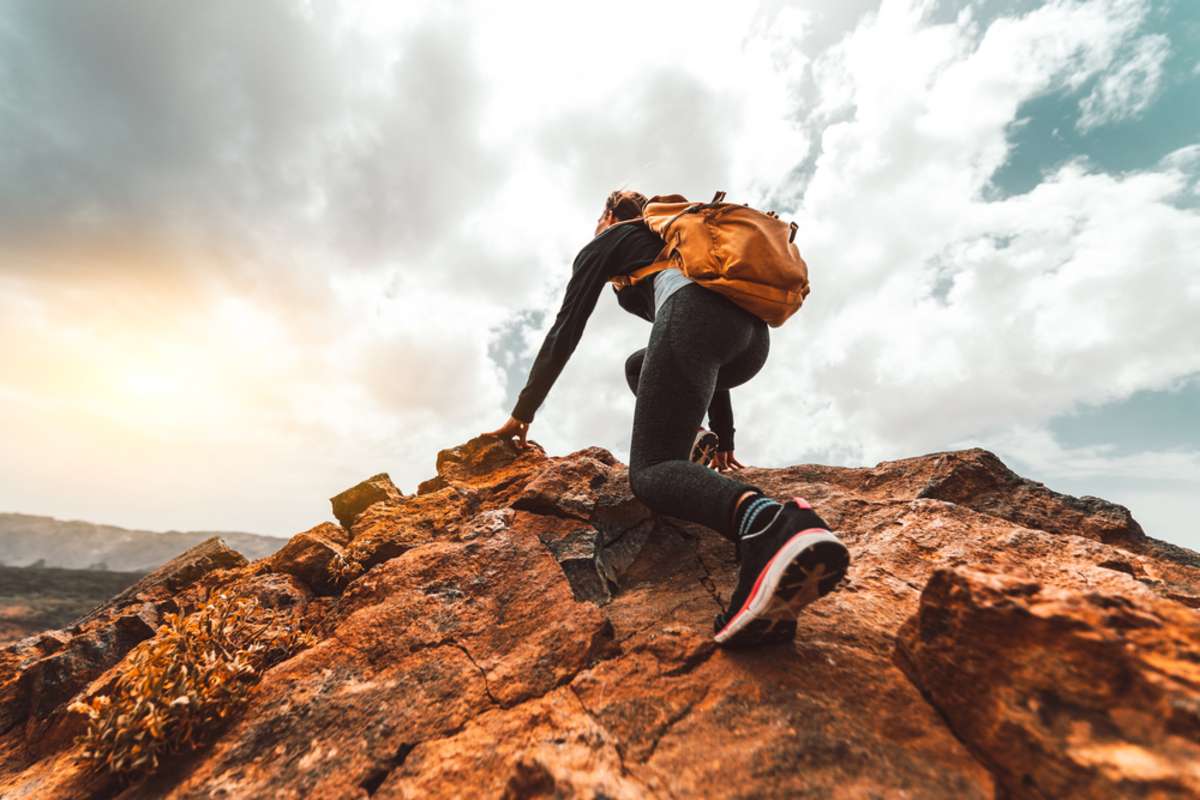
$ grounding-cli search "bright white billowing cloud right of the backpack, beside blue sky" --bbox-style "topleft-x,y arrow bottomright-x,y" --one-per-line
743,2 -> 1200,463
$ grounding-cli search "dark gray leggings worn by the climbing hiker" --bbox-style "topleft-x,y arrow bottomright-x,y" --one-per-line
625,283 -> 770,539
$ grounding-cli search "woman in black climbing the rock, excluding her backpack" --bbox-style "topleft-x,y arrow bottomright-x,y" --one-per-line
491,191 -> 850,645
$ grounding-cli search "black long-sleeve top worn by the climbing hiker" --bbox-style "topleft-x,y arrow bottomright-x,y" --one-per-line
512,223 -> 733,450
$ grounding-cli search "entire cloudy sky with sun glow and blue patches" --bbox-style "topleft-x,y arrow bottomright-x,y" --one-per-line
0,0 -> 1200,548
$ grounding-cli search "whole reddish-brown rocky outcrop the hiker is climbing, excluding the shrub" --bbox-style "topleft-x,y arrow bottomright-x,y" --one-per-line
0,437 -> 1200,799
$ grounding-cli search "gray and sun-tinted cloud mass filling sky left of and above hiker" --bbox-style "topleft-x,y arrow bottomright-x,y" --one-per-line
0,0 -> 806,533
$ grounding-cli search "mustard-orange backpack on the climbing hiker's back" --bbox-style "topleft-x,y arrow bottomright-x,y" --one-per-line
611,192 -> 809,327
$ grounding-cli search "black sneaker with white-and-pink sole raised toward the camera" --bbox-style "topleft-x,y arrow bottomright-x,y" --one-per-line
713,498 -> 850,646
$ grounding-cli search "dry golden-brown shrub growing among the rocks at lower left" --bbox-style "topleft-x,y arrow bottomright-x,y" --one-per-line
70,593 -> 313,777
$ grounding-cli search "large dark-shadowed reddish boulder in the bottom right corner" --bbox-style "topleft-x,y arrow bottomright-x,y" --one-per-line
900,570 -> 1200,798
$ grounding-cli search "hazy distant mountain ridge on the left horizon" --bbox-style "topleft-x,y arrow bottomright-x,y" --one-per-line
0,513 -> 287,572
